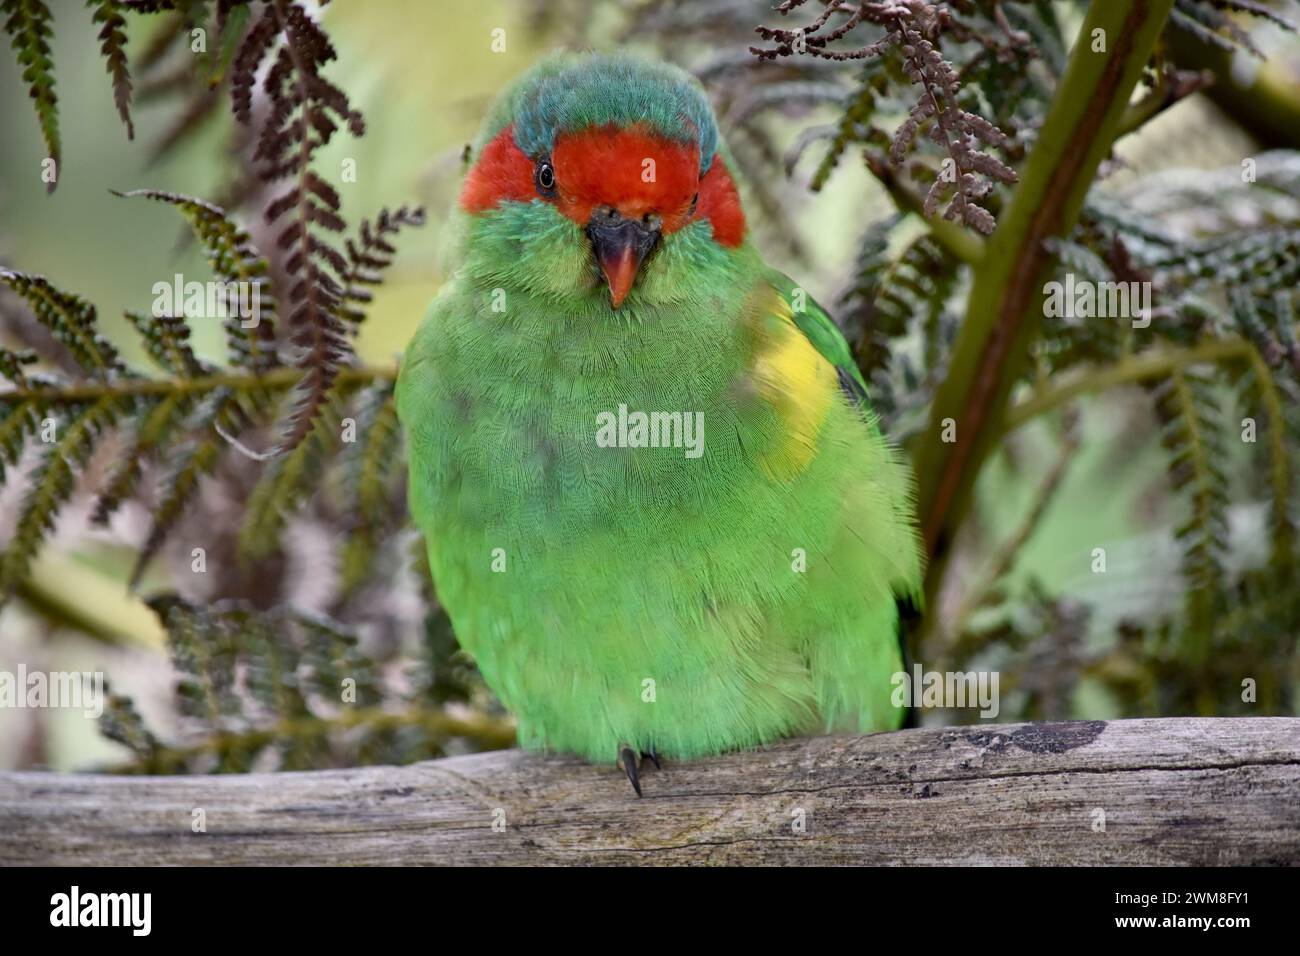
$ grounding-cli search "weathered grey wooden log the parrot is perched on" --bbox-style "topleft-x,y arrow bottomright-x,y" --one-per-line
0,718 -> 1300,865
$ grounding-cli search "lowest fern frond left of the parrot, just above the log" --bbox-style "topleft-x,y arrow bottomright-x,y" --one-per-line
103,594 -> 514,774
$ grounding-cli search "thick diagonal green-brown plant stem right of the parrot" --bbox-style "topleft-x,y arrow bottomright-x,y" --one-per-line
914,0 -> 1174,600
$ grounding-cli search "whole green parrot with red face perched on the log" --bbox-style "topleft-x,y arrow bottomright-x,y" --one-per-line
397,53 -> 922,796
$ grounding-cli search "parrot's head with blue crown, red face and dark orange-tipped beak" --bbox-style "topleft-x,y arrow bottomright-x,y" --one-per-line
460,53 -> 745,308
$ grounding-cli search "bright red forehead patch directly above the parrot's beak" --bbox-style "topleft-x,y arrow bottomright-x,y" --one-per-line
551,127 -> 699,232
